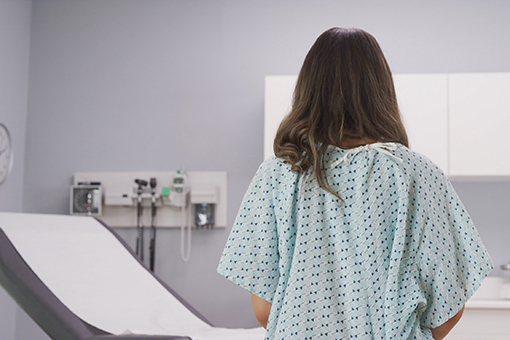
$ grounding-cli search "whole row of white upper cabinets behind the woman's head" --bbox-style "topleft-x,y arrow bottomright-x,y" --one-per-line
264,73 -> 510,176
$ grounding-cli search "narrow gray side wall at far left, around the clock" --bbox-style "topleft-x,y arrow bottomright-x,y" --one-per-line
0,0 -> 31,340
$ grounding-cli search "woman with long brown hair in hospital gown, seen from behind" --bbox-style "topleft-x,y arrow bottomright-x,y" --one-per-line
218,28 -> 492,340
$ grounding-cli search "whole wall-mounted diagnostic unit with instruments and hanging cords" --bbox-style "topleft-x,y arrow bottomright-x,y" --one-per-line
70,170 -> 227,269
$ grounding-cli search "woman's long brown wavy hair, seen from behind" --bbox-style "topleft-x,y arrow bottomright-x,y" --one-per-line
274,28 -> 408,197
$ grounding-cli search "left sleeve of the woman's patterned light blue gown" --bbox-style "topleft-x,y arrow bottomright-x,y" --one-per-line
218,162 -> 279,302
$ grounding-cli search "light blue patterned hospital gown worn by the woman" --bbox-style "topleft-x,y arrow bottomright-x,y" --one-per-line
218,143 -> 493,340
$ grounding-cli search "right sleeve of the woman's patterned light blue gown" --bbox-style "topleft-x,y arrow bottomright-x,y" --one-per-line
417,169 -> 493,328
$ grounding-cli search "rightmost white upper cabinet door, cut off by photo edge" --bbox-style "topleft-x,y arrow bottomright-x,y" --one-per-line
449,73 -> 510,176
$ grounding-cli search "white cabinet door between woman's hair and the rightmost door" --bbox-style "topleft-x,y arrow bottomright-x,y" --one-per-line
393,74 -> 449,173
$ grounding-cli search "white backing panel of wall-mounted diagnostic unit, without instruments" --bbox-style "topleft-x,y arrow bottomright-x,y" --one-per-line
73,171 -> 227,228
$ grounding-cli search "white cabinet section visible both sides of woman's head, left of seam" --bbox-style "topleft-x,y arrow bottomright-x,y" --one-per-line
264,74 -> 448,171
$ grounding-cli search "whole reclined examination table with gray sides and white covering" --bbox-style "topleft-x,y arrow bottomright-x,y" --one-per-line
0,213 -> 264,340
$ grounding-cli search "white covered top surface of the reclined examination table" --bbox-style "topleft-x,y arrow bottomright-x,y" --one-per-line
0,213 -> 264,340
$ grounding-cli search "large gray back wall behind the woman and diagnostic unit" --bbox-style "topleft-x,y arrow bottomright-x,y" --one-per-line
0,0 -> 510,339
